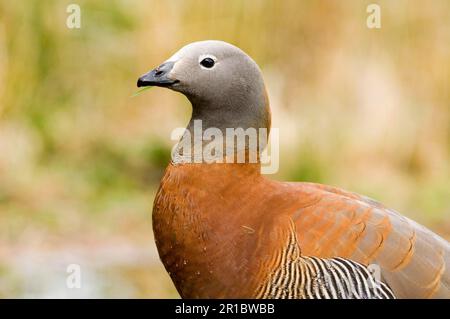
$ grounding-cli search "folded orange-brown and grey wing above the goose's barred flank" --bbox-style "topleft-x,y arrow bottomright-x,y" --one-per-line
294,183 -> 450,298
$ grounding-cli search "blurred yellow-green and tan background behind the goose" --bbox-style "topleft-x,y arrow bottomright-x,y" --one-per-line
0,0 -> 450,298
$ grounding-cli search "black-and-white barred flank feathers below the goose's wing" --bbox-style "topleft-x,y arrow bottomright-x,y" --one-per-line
257,226 -> 395,299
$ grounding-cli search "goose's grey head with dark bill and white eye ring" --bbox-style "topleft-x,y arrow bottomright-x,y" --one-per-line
137,40 -> 270,130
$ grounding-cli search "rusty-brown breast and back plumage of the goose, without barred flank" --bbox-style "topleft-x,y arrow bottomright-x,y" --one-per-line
153,164 -> 450,298
